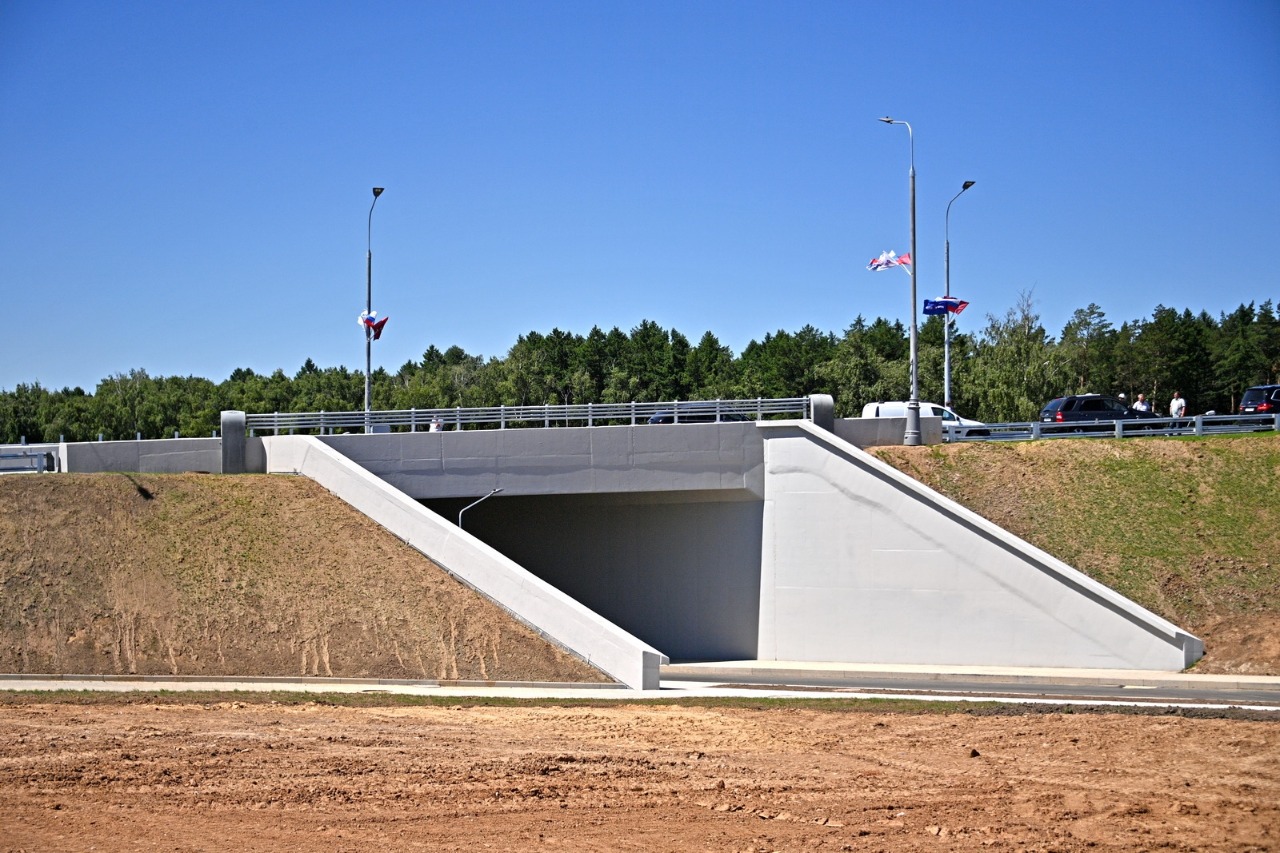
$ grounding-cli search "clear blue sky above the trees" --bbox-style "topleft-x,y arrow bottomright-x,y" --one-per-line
0,0 -> 1280,391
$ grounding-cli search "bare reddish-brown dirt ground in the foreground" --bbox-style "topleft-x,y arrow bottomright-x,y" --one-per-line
0,702 -> 1280,853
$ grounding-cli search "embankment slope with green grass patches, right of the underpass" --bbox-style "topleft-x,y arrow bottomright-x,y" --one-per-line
874,433 -> 1280,675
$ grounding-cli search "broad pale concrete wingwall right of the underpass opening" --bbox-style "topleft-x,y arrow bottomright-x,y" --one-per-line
759,421 -> 1204,670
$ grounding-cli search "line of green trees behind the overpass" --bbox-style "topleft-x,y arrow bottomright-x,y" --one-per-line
0,293 -> 1280,443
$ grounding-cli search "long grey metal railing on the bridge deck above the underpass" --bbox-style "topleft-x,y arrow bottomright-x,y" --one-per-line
244,397 -> 813,435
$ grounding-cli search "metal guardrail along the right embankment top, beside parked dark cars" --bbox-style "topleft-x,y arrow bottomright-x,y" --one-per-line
943,415 -> 1280,442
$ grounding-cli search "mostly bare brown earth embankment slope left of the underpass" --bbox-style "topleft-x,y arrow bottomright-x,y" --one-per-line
0,474 -> 608,681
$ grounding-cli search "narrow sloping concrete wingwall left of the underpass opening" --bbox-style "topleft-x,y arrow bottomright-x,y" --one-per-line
261,435 -> 667,689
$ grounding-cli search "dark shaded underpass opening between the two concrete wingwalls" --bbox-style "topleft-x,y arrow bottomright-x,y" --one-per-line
422,489 -> 764,661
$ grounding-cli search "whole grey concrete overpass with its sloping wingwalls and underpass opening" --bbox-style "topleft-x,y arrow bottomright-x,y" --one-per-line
37,406 -> 1203,688
